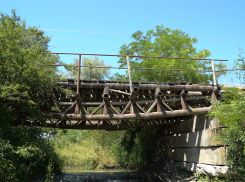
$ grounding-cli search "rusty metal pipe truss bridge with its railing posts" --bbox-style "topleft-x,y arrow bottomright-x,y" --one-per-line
18,53 -> 226,130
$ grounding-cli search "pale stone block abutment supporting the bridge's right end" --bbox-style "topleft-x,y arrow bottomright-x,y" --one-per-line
168,114 -> 228,177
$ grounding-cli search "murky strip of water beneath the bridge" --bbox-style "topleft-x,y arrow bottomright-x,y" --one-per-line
33,168 -> 146,182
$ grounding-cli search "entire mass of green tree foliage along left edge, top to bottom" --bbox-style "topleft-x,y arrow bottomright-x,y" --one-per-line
0,10 -> 64,181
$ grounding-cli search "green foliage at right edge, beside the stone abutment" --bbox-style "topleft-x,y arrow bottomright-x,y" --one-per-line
211,49 -> 245,181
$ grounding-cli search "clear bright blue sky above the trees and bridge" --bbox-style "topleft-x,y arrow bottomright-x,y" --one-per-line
0,0 -> 245,82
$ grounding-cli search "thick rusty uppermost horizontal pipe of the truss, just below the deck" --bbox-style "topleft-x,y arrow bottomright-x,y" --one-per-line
57,82 -> 214,91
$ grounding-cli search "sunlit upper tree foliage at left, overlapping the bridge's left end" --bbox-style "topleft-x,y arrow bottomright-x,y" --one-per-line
0,11 -> 66,121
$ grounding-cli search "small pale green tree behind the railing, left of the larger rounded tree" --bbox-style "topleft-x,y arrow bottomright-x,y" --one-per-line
66,56 -> 110,80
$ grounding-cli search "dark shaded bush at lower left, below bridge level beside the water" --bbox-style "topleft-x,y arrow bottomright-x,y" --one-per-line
0,122 -> 62,181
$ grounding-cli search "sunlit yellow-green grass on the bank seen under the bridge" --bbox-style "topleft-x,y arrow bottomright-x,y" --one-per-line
53,130 -> 120,169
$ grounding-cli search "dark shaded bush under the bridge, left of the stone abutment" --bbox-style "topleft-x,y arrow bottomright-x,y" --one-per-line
115,127 -> 167,169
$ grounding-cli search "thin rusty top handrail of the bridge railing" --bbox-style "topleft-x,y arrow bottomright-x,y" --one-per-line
43,52 -> 228,61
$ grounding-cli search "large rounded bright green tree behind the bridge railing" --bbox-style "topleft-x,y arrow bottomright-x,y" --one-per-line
118,25 -> 224,83
